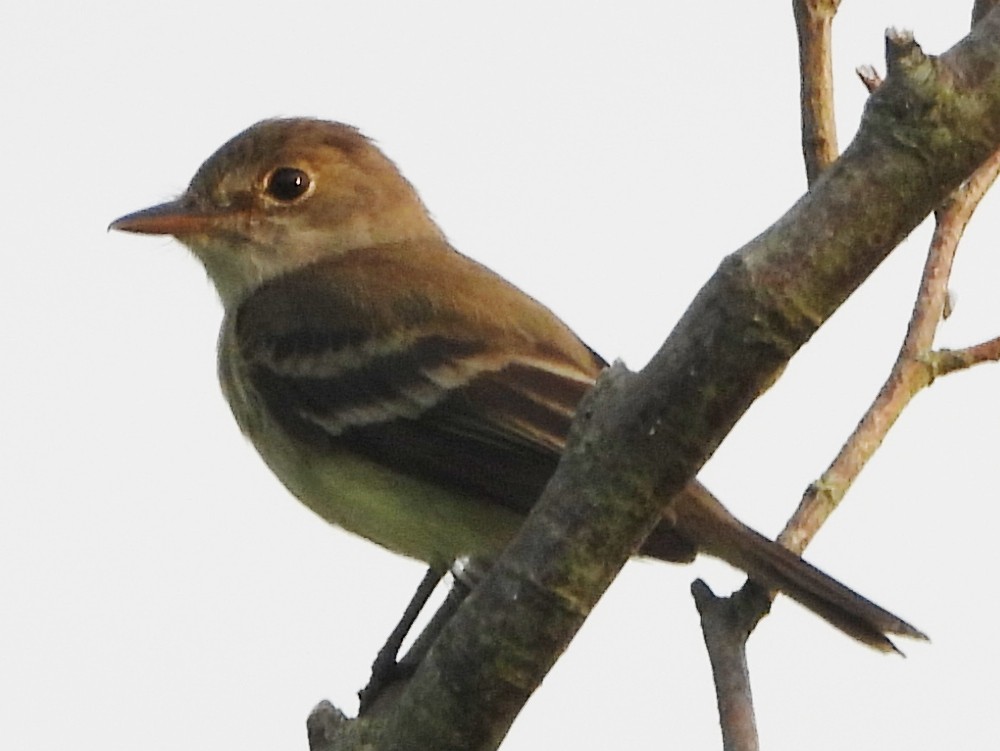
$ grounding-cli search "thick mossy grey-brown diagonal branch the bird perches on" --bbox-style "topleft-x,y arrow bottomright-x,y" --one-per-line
312,13 -> 1000,751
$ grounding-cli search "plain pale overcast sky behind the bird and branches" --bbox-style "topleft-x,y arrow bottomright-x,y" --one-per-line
0,0 -> 1000,751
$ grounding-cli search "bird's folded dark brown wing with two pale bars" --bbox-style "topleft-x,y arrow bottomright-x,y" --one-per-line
236,245 -> 603,512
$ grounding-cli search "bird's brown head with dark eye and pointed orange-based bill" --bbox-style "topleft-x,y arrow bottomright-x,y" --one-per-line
111,118 -> 441,307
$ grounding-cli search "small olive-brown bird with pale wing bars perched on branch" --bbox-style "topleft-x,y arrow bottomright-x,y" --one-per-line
110,118 -> 926,651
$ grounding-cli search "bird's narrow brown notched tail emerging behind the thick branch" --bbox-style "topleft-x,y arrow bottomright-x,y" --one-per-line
643,481 -> 927,652
